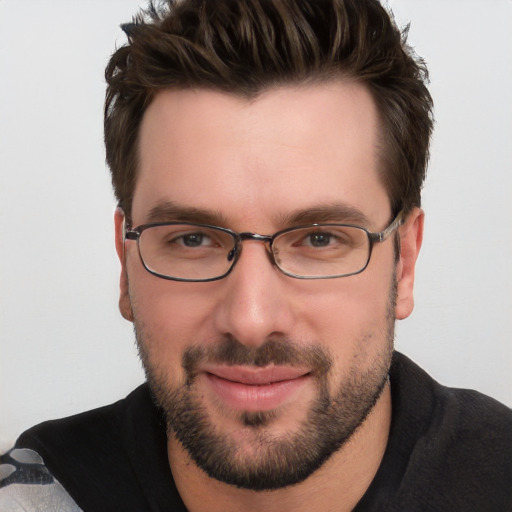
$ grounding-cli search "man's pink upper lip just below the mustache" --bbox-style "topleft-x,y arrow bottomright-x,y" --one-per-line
203,365 -> 309,386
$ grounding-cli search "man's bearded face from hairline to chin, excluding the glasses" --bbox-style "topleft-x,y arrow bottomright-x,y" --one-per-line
116,82 -> 422,489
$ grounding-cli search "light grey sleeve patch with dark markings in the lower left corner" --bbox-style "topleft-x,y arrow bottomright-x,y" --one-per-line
0,448 -> 81,512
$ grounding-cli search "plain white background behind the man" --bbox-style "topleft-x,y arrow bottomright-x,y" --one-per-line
0,0 -> 512,449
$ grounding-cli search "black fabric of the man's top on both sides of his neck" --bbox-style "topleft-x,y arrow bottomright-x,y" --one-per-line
5,353 -> 512,512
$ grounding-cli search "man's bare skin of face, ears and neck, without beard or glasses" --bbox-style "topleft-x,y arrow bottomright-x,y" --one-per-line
115,82 -> 423,511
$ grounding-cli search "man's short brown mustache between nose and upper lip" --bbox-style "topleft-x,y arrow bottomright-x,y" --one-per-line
182,336 -> 332,378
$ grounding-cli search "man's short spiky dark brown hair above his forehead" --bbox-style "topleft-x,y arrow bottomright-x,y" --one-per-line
105,0 -> 433,217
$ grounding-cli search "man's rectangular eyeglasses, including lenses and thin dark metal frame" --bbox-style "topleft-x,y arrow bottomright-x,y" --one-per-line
124,212 -> 403,282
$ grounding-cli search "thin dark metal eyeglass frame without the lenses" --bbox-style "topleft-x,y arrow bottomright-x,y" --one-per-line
123,210 -> 405,283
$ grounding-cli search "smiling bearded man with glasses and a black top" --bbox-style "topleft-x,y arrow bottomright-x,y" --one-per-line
0,0 -> 512,511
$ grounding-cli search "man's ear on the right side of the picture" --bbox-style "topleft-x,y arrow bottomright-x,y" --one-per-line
395,208 -> 425,320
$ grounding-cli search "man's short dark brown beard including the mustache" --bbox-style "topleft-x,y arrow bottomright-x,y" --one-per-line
134,281 -> 396,491
